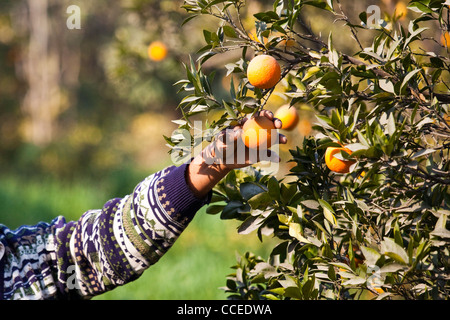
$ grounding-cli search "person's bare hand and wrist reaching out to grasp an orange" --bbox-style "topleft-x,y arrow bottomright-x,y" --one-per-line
186,110 -> 287,198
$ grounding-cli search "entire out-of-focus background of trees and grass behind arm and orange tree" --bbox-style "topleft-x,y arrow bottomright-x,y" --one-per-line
0,0 -> 446,299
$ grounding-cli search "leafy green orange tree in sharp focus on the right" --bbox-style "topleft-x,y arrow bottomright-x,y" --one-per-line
166,0 -> 450,299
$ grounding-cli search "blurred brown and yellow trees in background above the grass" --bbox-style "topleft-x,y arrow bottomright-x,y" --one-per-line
0,0 -> 217,178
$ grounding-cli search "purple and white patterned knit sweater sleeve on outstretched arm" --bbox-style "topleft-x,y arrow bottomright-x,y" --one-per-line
0,164 -> 211,300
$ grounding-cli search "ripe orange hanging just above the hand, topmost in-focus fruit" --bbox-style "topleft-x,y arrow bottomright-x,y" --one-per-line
247,54 -> 281,89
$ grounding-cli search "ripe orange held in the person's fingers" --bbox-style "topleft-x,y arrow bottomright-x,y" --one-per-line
242,116 -> 276,149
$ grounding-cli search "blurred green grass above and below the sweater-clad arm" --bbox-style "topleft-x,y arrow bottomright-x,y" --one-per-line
0,171 -> 273,300
